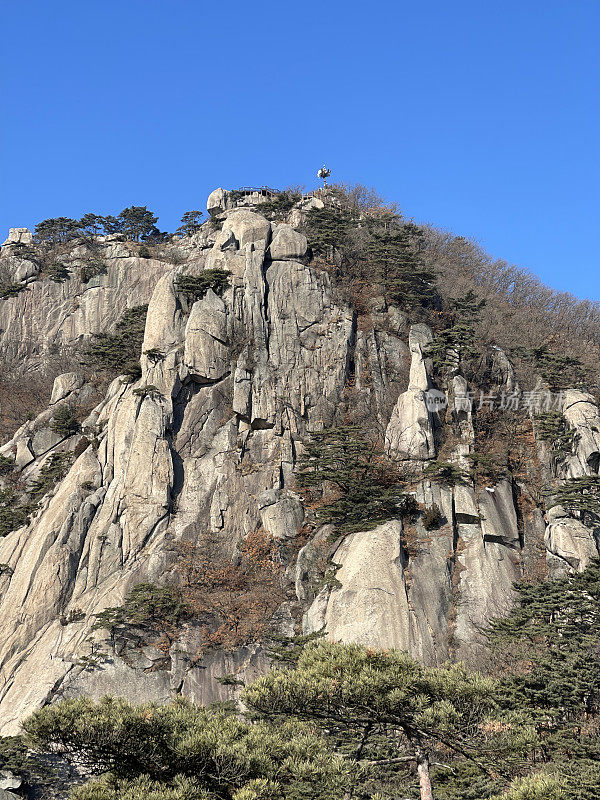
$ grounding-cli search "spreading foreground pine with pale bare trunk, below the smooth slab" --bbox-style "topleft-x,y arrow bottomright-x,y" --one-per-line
243,641 -> 502,800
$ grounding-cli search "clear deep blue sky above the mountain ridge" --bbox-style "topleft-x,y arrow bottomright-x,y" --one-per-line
0,0 -> 600,299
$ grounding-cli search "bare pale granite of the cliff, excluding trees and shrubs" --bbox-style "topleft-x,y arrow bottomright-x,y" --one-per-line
0,190 -> 600,735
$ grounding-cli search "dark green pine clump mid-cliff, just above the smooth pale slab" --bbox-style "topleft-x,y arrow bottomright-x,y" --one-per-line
296,425 -> 417,532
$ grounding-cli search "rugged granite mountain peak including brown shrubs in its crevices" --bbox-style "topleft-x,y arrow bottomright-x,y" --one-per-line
0,187 -> 600,734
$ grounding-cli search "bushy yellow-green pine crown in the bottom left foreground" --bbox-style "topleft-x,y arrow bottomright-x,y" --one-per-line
24,697 -> 353,800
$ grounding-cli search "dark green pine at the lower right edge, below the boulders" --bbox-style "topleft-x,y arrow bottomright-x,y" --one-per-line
487,559 -> 600,800
